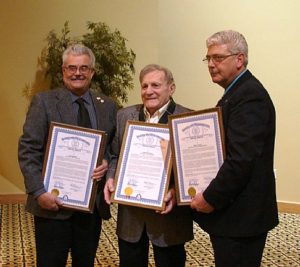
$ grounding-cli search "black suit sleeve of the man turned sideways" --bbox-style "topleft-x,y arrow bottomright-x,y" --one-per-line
203,88 -> 271,209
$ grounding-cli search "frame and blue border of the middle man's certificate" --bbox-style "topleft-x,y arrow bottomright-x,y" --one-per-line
112,121 -> 171,210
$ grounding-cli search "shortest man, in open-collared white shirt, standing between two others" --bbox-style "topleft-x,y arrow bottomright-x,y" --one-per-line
104,64 -> 193,267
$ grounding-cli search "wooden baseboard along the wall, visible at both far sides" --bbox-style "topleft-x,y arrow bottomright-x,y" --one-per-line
0,194 -> 300,214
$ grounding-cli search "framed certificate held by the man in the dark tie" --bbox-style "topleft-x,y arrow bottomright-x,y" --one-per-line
43,122 -> 106,213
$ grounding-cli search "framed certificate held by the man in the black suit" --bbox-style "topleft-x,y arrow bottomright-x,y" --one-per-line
169,107 -> 225,205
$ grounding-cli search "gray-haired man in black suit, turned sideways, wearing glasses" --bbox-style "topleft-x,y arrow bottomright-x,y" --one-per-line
191,31 -> 278,267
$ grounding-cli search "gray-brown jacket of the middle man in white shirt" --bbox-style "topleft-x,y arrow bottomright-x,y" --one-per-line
107,103 -> 193,247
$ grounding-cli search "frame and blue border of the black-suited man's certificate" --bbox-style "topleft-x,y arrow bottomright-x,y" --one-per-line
169,107 -> 225,205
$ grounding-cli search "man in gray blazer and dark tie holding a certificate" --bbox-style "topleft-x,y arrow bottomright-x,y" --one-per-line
19,44 -> 116,267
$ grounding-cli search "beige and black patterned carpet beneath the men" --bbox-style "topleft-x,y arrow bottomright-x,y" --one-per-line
0,204 -> 300,267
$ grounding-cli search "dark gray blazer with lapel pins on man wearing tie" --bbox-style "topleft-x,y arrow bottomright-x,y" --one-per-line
19,88 -> 116,219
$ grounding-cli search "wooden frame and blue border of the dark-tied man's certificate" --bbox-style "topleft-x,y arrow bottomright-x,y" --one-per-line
43,122 -> 106,213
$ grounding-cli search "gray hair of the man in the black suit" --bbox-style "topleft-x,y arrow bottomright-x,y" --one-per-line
206,30 -> 248,67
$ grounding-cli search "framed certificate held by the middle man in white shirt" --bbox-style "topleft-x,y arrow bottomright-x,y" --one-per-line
112,121 -> 171,210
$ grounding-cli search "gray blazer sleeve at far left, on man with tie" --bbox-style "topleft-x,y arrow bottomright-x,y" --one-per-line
18,95 -> 48,196
